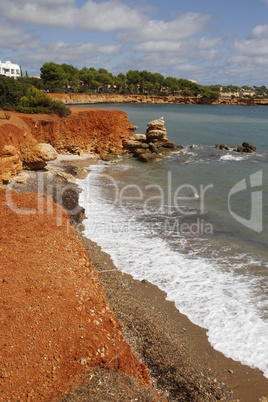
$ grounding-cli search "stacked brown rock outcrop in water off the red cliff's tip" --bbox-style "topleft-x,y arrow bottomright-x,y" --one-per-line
123,118 -> 183,163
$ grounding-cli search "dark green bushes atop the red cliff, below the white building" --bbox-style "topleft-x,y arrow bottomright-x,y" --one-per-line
0,75 -> 71,117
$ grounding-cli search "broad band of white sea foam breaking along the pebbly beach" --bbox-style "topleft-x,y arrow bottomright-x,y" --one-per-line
78,165 -> 268,377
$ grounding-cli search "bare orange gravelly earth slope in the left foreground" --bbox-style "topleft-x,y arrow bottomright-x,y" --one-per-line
0,190 -> 150,401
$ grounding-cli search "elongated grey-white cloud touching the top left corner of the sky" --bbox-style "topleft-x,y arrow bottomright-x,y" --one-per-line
0,0 -> 144,32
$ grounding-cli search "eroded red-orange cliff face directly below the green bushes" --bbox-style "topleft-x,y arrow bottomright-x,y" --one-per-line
0,109 -> 135,185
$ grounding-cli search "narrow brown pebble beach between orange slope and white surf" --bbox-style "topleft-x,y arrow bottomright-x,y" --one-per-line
8,156 -> 268,402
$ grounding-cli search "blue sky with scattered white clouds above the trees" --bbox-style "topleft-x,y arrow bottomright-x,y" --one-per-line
0,0 -> 268,86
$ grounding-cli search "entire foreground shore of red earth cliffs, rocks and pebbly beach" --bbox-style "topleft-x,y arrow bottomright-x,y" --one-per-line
0,111 -> 268,402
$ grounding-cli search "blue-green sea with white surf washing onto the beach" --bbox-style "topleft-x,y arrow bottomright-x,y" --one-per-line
78,104 -> 268,378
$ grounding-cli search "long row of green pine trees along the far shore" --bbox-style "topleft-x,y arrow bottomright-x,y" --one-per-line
40,62 -> 220,97
